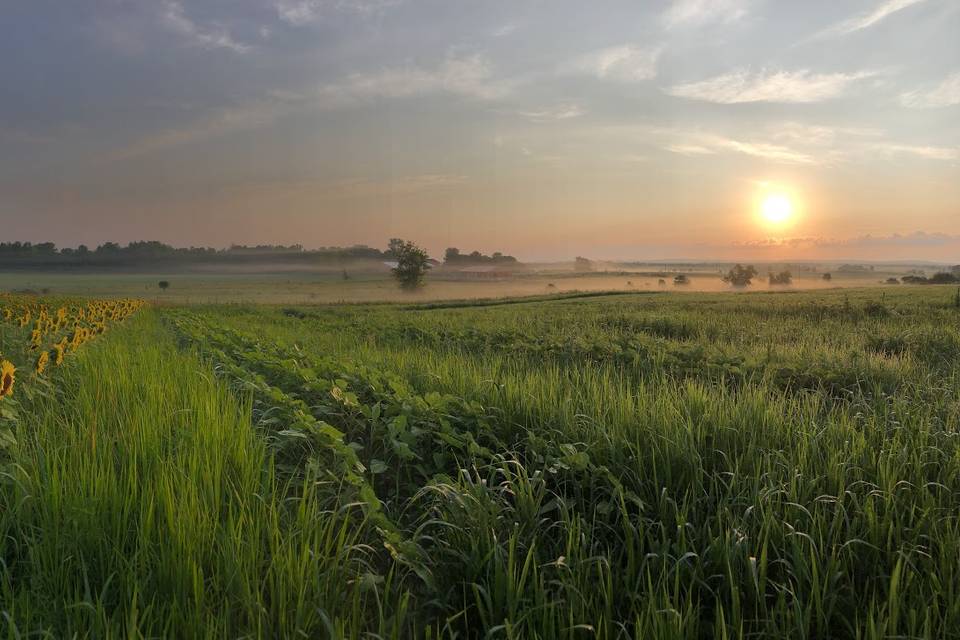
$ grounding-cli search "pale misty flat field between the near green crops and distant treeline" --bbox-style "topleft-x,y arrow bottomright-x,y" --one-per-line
0,265 -> 904,304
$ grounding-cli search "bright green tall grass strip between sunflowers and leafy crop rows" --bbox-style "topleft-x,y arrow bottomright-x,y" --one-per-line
0,312 -> 394,638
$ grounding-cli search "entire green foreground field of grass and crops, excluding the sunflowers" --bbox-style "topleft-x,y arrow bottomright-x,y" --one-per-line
0,286 -> 960,640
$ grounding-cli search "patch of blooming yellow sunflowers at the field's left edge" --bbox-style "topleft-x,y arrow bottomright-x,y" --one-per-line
0,294 -> 144,398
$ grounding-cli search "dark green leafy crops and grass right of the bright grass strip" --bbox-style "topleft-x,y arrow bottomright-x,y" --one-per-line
167,288 -> 960,638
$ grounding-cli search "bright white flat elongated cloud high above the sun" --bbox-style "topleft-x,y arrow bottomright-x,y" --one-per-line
665,69 -> 880,104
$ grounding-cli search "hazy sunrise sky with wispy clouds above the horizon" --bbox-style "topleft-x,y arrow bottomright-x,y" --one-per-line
0,0 -> 960,263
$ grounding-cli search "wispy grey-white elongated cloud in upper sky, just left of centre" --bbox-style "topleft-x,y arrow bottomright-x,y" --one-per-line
320,55 -> 511,105
